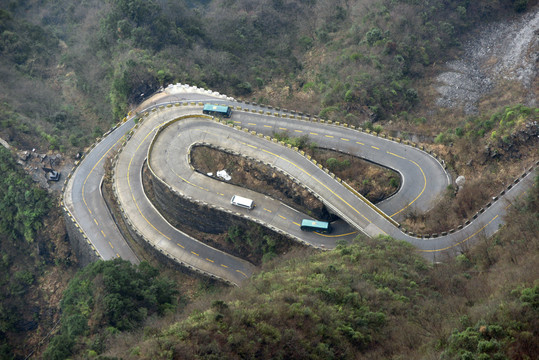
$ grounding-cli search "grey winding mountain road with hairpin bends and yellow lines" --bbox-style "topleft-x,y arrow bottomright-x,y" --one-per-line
64,85 -> 532,285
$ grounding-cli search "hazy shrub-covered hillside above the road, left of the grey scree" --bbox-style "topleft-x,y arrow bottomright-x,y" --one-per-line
0,0 -> 528,150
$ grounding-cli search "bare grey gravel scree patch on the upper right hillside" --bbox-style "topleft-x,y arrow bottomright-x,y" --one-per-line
436,7 -> 539,114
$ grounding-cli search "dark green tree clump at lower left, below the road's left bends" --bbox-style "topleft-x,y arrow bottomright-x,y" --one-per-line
43,259 -> 178,359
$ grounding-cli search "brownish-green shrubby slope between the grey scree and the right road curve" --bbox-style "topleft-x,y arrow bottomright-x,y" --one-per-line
405,104 -> 539,233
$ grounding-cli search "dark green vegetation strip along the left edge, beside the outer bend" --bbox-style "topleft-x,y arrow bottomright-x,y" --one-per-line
0,146 -> 51,358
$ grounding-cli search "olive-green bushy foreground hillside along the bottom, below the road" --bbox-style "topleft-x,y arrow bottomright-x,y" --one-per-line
45,175 -> 539,359
